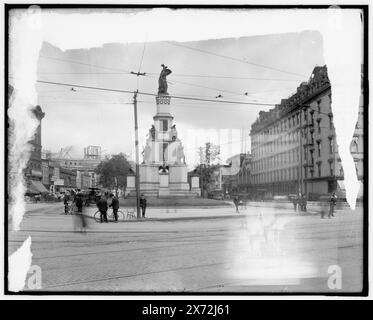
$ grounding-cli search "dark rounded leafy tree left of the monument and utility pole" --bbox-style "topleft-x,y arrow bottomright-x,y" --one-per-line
95,153 -> 131,189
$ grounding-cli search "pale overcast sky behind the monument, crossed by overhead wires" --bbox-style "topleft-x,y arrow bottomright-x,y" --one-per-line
37,31 -> 324,166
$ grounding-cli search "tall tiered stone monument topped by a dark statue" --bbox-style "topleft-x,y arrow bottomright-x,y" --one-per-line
126,64 -> 201,198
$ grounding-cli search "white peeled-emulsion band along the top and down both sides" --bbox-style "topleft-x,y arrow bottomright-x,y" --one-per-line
8,6 -> 362,292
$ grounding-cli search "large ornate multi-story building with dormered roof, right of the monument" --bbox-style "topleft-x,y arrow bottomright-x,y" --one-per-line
250,66 -> 363,196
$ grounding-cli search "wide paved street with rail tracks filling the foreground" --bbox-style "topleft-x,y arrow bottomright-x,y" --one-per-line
8,203 -> 363,293
